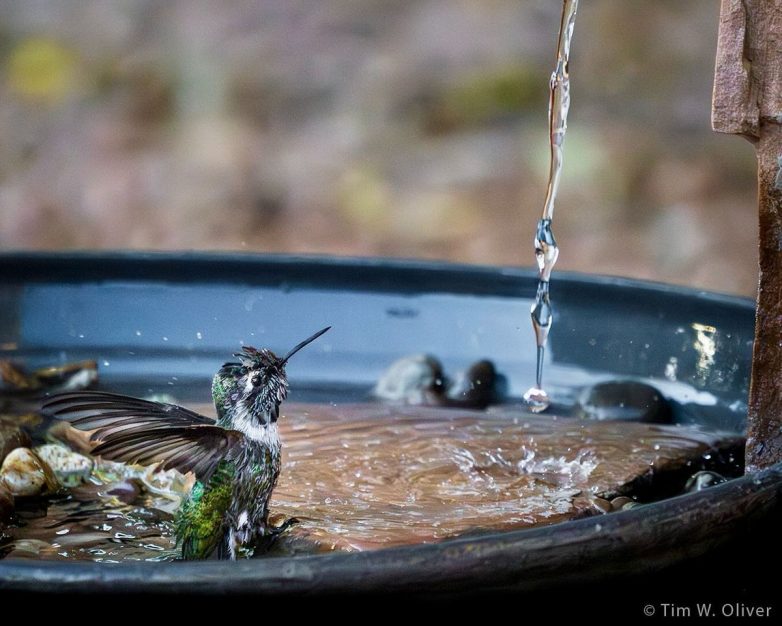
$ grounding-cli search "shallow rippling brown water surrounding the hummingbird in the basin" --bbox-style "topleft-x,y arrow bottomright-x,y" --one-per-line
0,405 -> 736,561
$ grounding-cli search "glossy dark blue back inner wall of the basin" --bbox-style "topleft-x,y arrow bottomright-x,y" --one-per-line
0,254 -> 753,422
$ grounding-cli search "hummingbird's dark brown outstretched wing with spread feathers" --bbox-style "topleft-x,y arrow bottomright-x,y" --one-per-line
43,391 -> 244,480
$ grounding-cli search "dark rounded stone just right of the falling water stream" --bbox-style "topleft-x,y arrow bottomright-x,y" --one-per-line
576,380 -> 671,424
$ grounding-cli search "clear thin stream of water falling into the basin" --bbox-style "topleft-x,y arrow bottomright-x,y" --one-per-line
524,0 -> 578,413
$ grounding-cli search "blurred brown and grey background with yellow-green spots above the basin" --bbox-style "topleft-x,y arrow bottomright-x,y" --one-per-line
0,0 -> 756,295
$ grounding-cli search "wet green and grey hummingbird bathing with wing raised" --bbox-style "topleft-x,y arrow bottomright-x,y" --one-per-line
43,326 -> 331,560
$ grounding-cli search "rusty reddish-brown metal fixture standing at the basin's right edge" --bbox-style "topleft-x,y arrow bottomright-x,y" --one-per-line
712,0 -> 782,473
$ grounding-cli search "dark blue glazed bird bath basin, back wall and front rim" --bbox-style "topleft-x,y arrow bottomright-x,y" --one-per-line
0,254 -> 782,594
